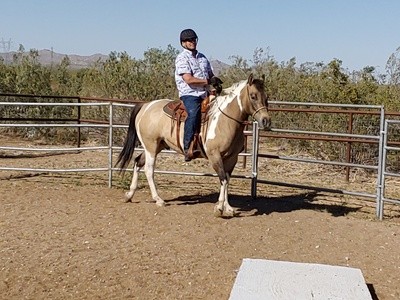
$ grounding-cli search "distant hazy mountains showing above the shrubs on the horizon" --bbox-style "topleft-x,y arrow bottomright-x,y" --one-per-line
0,49 -> 229,76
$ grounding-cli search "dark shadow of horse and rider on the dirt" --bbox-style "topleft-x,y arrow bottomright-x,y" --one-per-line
168,192 -> 359,217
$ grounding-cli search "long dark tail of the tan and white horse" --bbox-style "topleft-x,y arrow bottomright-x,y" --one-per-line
115,103 -> 143,172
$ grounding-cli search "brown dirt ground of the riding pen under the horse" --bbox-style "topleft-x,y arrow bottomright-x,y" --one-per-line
0,137 -> 400,300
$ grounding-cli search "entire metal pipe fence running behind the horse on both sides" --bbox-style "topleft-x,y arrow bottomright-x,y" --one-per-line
0,96 -> 400,219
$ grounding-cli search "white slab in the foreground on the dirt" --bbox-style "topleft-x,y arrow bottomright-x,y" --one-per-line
229,258 -> 372,300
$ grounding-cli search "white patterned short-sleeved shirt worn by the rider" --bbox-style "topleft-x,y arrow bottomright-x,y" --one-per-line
175,49 -> 212,98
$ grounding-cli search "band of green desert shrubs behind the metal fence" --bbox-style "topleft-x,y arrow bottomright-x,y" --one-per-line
0,45 -> 400,169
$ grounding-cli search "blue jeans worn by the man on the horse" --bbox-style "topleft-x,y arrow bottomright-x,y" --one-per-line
181,96 -> 203,151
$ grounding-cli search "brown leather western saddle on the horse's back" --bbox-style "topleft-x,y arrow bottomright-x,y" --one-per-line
163,95 -> 215,159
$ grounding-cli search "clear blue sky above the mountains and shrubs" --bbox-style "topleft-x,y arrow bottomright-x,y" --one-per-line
0,0 -> 400,73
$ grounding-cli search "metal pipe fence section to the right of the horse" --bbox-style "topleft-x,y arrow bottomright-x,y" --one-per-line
252,102 -> 400,219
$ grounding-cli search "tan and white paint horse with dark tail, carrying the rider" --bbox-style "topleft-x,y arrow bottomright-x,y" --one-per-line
116,74 -> 271,217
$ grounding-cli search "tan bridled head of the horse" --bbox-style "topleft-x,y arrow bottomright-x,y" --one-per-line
240,74 -> 271,130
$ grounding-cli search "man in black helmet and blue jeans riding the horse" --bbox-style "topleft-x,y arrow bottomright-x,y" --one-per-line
175,29 -> 222,161
